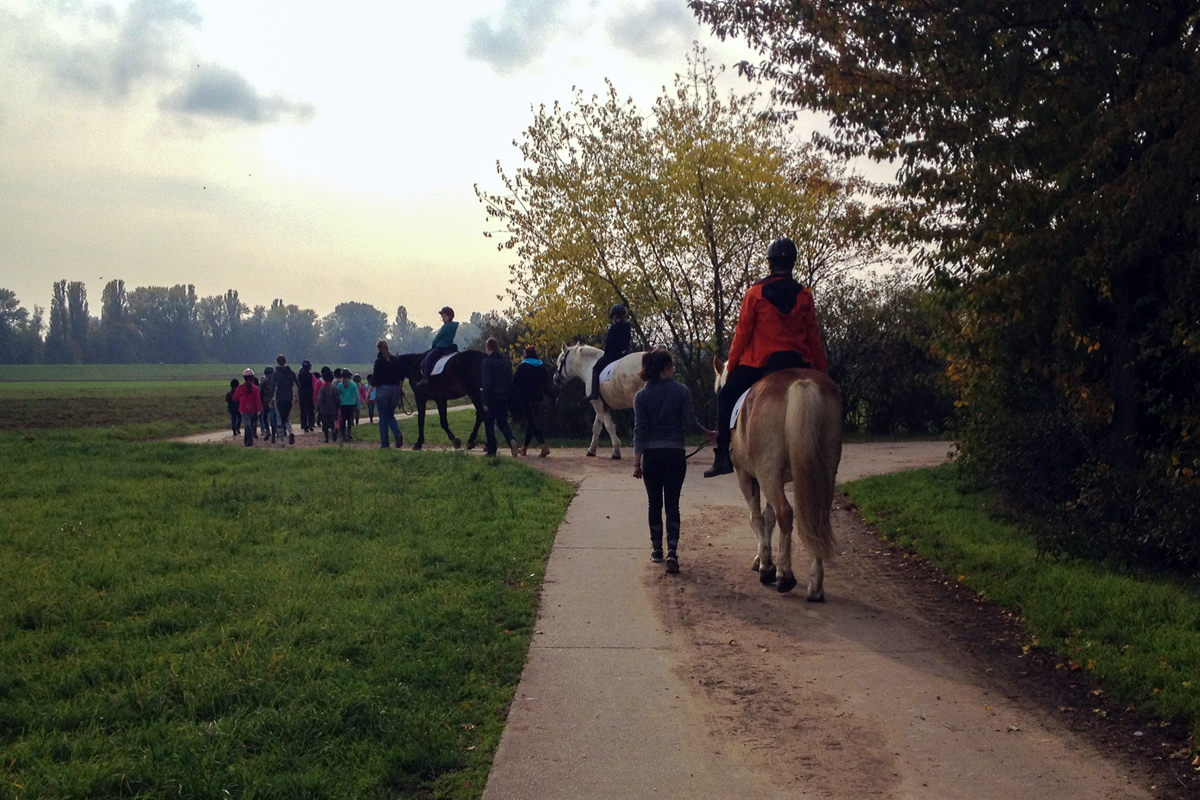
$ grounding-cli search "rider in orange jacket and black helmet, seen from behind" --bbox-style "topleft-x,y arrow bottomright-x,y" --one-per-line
704,237 -> 828,477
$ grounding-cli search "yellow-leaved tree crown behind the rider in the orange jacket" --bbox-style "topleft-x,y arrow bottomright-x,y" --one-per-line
476,50 -> 883,407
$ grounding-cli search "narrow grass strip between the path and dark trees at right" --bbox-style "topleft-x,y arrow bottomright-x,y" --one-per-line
845,464 -> 1200,734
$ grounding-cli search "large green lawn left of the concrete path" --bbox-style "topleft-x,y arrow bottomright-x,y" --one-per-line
0,428 -> 572,799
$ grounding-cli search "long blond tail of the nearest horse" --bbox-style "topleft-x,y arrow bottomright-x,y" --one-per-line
785,375 -> 841,559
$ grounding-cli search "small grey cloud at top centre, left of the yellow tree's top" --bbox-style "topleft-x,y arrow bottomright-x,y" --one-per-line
467,0 -> 569,74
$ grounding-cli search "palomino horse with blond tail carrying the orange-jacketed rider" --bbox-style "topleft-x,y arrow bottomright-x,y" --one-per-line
713,359 -> 841,602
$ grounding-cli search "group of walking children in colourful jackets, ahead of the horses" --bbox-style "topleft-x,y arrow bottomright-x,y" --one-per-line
226,355 -> 376,447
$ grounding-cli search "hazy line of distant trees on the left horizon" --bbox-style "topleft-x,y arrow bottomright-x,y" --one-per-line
0,281 -> 496,363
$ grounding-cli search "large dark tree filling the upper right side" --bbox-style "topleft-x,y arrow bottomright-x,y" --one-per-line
690,0 -> 1200,569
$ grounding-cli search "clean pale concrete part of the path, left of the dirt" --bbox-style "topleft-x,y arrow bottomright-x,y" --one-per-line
484,441 -> 950,800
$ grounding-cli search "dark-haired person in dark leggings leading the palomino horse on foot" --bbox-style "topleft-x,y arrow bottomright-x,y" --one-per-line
634,350 -> 716,575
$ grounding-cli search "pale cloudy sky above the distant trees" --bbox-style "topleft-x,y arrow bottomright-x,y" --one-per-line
0,0 -> 772,325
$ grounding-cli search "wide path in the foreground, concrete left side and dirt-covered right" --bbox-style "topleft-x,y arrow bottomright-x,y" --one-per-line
484,443 -> 1150,800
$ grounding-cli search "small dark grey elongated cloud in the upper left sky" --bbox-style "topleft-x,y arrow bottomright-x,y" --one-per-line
161,65 -> 317,125
